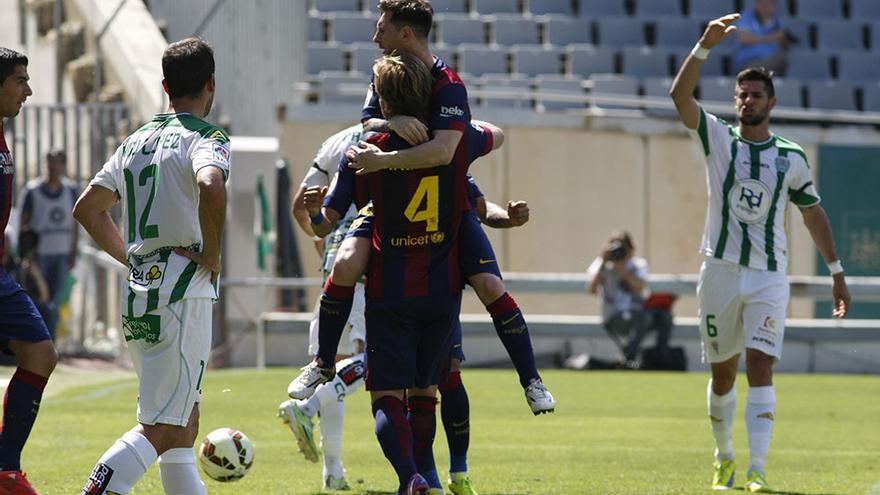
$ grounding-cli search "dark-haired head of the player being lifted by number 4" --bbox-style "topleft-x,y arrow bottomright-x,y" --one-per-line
373,0 -> 434,55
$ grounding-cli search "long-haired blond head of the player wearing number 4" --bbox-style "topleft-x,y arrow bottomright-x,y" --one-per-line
373,52 -> 434,121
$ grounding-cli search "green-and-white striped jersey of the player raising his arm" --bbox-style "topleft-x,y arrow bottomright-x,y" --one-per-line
691,108 -> 819,272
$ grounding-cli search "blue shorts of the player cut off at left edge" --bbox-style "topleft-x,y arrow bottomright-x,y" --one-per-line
0,270 -> 52,354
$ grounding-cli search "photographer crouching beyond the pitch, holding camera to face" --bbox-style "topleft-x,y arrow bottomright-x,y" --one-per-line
587,232 -> 648,363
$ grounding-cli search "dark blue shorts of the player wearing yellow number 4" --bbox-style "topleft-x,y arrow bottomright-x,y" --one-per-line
365,292 -> 461,390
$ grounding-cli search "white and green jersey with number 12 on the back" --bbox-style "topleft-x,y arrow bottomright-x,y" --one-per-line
91,113 -> 230,318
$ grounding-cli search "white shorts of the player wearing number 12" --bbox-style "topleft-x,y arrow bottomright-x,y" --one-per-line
122,298 -> 213,426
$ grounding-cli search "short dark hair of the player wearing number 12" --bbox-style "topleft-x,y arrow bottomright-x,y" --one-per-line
162,37 -> 214,99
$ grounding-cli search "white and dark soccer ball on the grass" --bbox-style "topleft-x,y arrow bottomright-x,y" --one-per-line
199,428 -> 254,481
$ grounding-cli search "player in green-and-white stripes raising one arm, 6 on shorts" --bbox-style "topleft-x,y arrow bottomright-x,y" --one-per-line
670,14 -> 850,492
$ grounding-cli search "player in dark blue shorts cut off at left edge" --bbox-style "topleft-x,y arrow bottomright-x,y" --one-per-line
0,47 -> 58,495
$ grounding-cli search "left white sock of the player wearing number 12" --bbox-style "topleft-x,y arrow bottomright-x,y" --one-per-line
83,431 -> 157,495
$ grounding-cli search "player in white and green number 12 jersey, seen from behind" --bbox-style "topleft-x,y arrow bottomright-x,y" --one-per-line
74,38 -> 230,495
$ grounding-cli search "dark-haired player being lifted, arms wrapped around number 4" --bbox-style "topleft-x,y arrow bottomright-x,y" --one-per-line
291,0 -> 556,414
